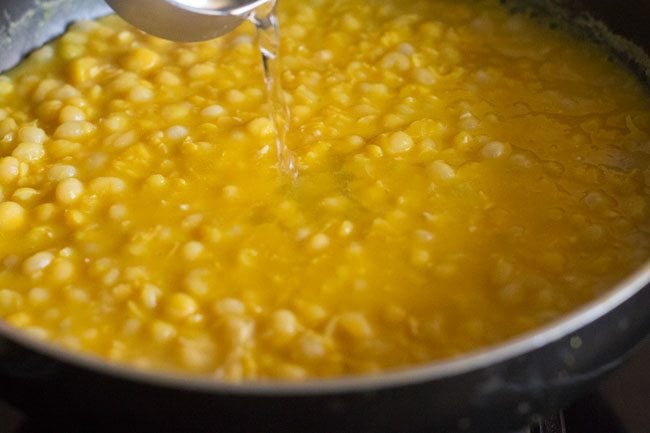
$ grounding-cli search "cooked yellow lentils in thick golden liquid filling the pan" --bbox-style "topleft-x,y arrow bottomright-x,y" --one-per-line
0,0 -> 650,381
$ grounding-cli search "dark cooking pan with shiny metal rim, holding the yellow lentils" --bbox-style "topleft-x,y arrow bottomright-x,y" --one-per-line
0,0 -> 650,432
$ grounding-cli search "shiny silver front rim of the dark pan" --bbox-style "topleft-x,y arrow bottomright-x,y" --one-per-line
0,262 -> 650,395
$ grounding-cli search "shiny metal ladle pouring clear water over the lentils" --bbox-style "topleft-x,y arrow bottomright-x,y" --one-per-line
106,0 -> 273,42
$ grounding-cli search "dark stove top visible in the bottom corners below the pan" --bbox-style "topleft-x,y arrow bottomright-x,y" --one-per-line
0,339 -> 650,433
